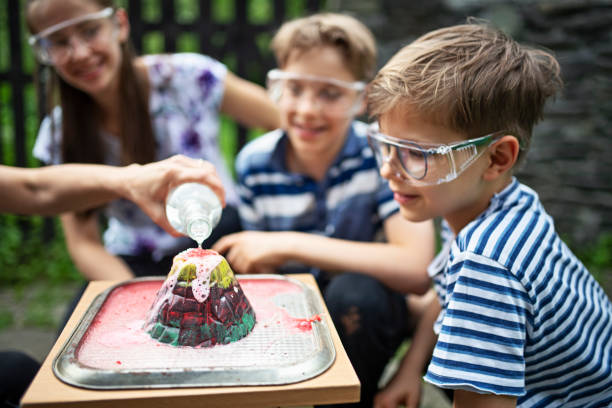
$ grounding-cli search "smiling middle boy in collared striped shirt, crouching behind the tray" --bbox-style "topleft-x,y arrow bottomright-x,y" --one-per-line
213,14 -> 434,407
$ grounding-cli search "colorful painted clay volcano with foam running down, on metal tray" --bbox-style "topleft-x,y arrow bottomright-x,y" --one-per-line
144,248 -> 255,347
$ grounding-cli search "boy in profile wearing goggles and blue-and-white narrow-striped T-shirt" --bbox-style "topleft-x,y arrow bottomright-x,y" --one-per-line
368,23 -> 612,408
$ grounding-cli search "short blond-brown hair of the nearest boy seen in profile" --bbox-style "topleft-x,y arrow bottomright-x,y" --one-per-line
368,21 -> 562,165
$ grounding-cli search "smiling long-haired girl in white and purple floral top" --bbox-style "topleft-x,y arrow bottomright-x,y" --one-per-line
27,0 -> 278,279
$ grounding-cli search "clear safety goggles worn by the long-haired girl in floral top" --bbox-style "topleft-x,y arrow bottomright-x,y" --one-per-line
28,7 -> 114,65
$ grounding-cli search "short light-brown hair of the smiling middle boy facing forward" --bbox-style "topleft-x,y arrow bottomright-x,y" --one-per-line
272,13 -> 376,81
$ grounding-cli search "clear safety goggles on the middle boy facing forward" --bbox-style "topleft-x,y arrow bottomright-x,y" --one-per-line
266,69 -> 366,117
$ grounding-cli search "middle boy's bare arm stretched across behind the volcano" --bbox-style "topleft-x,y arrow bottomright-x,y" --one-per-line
213,213 -> 434,294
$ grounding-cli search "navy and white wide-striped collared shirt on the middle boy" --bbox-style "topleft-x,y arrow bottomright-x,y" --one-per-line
236,121 -> 399,275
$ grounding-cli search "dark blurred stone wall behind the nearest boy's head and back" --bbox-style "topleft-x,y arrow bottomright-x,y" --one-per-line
328,0 -> 612,244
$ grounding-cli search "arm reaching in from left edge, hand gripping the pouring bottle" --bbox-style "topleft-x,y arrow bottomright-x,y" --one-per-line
0,155 -> 225,235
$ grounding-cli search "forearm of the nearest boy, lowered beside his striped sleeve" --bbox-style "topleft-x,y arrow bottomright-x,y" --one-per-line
374,289 -> 440,408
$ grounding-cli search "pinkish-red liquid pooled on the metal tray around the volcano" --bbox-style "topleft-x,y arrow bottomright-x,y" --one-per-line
76,278 -> 321,369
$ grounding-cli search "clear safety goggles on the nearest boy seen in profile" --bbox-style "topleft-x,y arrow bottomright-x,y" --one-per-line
368,123 -> 502,186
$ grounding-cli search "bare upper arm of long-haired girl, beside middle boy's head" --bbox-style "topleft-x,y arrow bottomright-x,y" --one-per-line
221,71 -> 280,130
